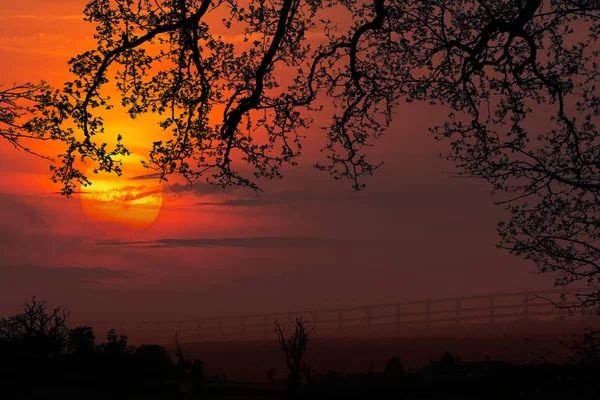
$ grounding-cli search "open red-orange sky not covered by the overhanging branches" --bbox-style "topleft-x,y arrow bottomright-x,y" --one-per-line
0,0 -> 552,320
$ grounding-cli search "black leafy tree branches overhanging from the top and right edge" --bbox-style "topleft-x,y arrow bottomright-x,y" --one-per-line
12,0 -> 600,305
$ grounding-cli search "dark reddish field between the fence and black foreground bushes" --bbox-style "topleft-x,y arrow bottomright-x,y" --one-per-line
168,334 -> 570,382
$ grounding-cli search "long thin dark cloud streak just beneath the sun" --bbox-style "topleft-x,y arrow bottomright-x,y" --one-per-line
99,236 -> 356,249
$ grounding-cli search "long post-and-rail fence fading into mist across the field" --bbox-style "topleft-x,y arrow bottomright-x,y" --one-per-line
70,289 -> 585,342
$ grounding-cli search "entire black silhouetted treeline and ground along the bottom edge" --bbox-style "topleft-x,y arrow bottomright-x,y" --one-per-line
0,298 -> 600,400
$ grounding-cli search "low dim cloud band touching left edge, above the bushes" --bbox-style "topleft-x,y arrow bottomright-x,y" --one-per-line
0,266 -> 137,286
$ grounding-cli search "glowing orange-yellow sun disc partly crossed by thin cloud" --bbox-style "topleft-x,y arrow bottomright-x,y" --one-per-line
80,167 -> 163,236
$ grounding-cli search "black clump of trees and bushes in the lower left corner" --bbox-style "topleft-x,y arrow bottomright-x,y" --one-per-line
0,298 -> 203,398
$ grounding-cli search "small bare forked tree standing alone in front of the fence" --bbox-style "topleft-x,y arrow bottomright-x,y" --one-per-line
275,316 -> 314,393
